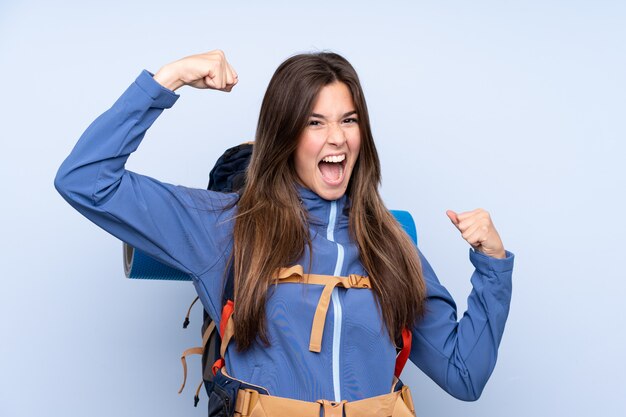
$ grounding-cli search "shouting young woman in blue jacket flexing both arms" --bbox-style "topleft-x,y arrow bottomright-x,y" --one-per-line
55,51 -> 513,416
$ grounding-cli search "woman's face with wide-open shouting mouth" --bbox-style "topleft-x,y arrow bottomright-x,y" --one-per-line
294,82 -> 361,200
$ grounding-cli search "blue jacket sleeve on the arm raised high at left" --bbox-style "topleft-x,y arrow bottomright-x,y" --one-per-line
54,71 -> 233,275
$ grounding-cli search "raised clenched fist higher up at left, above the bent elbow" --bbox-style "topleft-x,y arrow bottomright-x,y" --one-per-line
154,49 -> 238,92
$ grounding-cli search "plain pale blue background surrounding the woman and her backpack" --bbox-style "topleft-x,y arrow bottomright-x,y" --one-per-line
0,0 -> 626,417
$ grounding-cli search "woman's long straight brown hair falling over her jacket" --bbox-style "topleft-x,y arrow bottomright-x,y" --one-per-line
231,52 -> 426,350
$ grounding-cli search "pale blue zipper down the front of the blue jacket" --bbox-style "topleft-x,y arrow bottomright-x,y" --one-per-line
326,201 -> 344,402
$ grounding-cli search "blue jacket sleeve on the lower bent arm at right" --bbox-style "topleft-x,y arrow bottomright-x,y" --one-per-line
410,249 -> 514,401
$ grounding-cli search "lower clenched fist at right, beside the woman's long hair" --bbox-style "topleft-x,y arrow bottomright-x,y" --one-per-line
446,209 -> 506,258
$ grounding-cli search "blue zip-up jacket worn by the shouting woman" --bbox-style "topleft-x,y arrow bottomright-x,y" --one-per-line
55,71 -> 513,401
